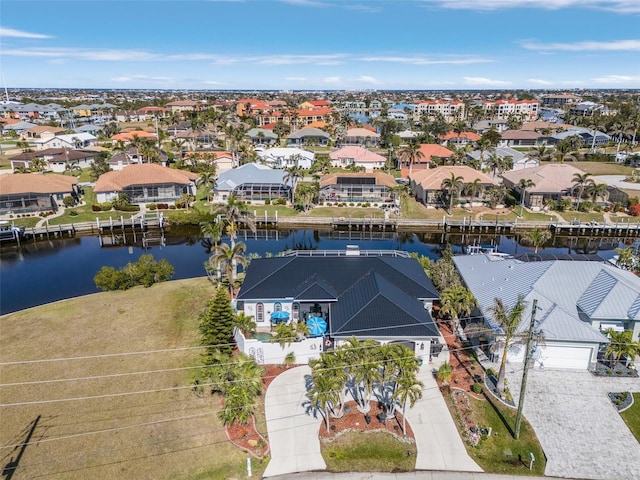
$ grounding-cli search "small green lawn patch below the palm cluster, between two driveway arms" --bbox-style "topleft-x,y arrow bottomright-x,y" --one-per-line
320,432 -> 416,472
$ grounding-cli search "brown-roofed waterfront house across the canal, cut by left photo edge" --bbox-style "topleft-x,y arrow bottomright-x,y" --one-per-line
0,173 -> 79,215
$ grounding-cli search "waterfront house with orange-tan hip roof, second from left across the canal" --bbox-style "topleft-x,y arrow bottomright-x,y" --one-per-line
94,163 -> 198,204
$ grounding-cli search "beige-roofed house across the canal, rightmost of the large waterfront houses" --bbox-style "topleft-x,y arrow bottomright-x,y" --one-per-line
502,163 -> 584,211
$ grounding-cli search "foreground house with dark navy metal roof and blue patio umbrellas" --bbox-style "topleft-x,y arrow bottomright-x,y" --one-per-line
236,249 -> 440,364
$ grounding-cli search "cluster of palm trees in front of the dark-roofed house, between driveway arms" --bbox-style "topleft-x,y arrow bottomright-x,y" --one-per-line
308,338 -> 424,434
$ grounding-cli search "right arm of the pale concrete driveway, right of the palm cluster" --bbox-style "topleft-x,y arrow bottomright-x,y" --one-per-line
407,362 -> 482,472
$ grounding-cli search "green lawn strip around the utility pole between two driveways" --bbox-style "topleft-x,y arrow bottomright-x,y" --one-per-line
460,398 -> 546,476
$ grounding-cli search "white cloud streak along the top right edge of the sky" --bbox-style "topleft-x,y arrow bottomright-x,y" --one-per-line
418,0 -> 640,13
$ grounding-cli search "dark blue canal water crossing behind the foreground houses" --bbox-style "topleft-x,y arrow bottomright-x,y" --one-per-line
0,228 -> 620,314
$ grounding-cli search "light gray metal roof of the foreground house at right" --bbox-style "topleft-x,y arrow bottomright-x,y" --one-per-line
454,255 -> 628,342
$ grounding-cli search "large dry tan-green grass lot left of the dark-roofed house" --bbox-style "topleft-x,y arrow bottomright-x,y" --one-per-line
0,278 -> 266,480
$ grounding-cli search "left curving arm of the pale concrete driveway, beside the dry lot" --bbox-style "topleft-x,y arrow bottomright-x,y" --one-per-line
264,366 -> 327,477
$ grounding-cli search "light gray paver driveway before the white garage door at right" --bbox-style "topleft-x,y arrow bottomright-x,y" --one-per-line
507,365 -> 640,480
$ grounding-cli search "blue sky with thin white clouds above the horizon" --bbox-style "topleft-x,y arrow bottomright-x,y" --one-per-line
0,0 -> 640,90
